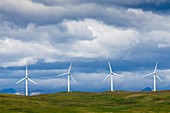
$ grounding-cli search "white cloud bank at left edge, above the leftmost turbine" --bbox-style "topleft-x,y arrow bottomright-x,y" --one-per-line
0,38 -> 57,67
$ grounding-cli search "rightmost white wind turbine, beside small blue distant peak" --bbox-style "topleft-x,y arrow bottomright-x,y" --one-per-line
143,62 -> 162,91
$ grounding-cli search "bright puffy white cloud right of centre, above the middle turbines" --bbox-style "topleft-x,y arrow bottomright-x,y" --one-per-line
64,19 -> 138,59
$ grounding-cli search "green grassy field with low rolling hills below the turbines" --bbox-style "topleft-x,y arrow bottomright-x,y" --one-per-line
0,91 -> 170,113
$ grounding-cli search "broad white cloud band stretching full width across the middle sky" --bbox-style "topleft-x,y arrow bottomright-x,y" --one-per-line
0,16 -> 170,67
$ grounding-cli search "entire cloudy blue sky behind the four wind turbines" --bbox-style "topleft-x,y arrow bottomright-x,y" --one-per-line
0,0 -> 170,92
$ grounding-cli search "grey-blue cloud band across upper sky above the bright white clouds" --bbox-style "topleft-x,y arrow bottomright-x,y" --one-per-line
0,0 -> 169,28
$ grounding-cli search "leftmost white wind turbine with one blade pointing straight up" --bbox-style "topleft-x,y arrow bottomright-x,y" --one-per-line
16,65 -> 37,96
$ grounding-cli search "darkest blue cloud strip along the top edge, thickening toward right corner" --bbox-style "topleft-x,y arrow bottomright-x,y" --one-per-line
33,0 -> 170,13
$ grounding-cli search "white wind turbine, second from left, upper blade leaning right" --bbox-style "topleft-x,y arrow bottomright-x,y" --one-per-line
57,63 -> 77,92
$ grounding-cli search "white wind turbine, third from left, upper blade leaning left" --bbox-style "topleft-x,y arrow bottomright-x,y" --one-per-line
103,61 -> 123,91
